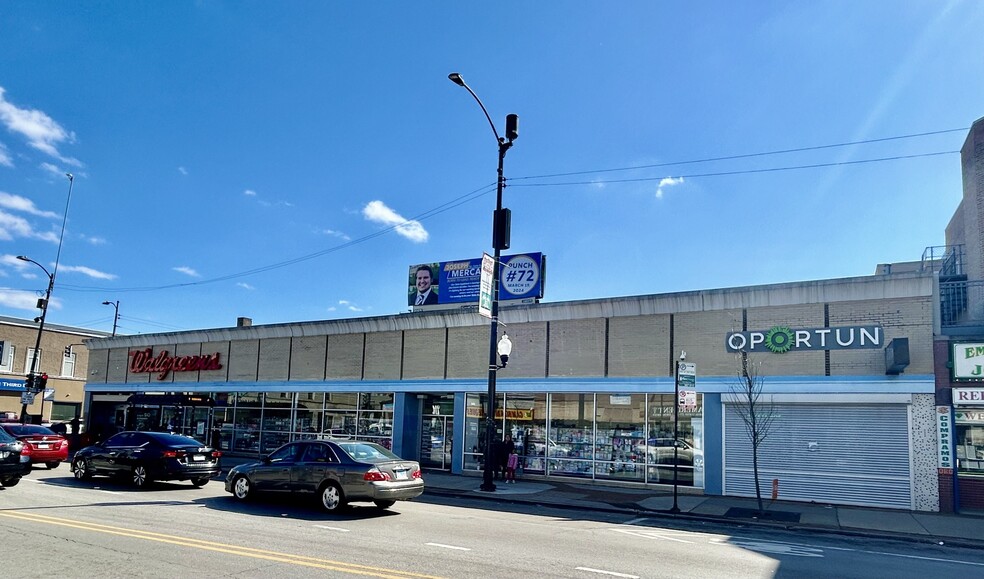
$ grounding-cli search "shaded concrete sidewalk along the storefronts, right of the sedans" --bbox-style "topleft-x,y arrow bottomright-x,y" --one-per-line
424,471 -> 984,549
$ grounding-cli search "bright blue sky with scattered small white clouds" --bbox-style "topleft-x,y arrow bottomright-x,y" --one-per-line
0,0 -> 984,334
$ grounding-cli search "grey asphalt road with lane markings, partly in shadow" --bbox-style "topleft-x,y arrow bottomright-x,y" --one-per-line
0,465 -> 984,579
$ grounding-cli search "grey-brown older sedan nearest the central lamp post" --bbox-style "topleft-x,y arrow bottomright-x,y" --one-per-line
225,440 -> 424,512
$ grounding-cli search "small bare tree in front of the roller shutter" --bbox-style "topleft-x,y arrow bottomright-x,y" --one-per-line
731,350 -> 778,513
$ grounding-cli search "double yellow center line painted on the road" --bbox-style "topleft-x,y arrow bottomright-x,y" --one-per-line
0,511 -> 440,579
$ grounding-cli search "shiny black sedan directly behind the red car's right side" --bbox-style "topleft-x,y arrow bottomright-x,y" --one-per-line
72,431 -> 222,488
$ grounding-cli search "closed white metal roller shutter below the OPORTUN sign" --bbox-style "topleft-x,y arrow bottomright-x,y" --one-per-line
724,404 -> 912,509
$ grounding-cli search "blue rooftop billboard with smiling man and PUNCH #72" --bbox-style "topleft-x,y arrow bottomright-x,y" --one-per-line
407,253 -> 546,306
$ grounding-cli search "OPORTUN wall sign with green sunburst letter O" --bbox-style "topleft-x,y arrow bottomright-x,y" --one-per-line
724,326 -> 885,354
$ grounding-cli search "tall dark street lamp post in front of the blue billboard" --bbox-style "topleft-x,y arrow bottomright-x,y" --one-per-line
448,72 -> 519,492
